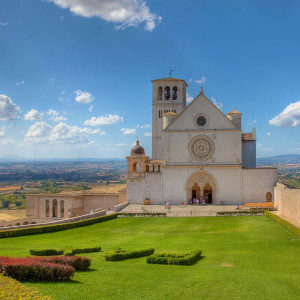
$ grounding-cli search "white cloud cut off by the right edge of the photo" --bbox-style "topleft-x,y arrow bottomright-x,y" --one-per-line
269,101 -> 300,127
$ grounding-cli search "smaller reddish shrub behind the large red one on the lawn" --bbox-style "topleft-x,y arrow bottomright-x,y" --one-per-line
36,256 -> 91,271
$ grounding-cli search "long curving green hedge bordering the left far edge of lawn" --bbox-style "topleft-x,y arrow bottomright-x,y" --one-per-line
0,213 -> 118,238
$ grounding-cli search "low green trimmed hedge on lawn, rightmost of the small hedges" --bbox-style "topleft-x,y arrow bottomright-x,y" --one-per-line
147,251 -> 202,266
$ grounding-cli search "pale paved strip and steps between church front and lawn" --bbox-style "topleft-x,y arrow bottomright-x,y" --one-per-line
121,204 -> 236,217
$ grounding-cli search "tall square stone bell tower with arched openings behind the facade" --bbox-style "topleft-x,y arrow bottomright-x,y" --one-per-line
152,77 -> 188,159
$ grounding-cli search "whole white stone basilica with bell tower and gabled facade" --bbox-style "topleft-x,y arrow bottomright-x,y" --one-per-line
126,77 -> 277,205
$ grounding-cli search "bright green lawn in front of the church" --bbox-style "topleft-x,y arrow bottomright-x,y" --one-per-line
0,216 -> 300,299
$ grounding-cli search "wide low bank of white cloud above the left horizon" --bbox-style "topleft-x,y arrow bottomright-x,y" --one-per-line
25,122 -> 99,144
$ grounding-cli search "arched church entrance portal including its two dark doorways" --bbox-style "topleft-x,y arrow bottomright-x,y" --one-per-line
185,170 -> 217,204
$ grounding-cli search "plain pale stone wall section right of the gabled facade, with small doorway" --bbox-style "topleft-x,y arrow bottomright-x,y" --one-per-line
242,168 -> 278,203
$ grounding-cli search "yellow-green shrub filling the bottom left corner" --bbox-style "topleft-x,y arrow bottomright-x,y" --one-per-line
0,274 -> 51,300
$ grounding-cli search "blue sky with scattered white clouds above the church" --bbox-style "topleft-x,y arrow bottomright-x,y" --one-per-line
0,0 -> 300,158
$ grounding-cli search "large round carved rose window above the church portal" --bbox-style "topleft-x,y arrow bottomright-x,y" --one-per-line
189,135 -> 215,160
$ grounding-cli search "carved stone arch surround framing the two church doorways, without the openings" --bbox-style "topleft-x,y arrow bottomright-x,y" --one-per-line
185,170 -> 218,204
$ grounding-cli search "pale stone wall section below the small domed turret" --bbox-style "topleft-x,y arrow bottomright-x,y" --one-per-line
126,172 -> 162,204
